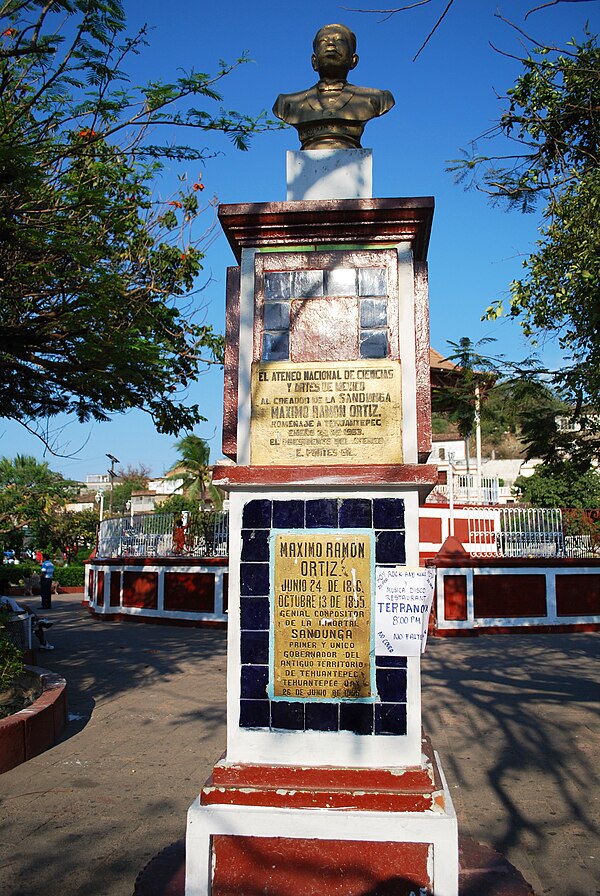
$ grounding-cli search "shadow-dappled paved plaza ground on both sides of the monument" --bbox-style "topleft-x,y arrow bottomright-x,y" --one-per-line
0,595 -> 600,896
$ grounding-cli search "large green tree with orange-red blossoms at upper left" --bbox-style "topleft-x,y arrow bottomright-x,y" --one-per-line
0,0 -> 264,448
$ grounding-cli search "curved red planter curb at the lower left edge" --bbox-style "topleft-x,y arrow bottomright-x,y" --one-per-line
0,666 -> 67,774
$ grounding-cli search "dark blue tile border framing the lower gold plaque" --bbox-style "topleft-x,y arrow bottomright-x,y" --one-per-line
240,498 -> 407,735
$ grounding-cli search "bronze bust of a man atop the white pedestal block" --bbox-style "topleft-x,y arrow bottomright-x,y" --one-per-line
273,25 -> 394,149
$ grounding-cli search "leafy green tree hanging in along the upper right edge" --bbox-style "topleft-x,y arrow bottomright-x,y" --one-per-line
452,34 -> 600,459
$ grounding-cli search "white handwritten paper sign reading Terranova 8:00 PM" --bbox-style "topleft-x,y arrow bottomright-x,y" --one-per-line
375,567 -> 435,656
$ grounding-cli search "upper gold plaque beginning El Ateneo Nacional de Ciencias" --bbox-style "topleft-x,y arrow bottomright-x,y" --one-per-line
250,360 -> 402,466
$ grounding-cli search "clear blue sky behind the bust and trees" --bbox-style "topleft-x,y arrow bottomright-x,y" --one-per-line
0,0 -> 600,479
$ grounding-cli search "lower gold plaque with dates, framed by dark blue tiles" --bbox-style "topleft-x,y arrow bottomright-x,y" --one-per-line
272,533 -> 371,700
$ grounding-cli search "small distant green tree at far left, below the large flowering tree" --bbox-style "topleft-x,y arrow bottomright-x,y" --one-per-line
0,454 -> 74,548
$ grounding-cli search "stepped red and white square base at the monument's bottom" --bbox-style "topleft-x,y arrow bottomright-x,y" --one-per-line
185,741 -> 458,896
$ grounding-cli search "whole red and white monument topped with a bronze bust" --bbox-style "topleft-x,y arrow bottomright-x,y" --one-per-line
186,25 -> 458,896
